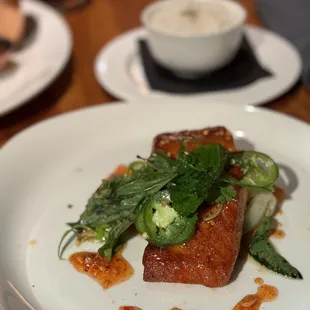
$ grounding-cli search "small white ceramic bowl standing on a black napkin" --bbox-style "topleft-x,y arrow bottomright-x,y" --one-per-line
141,0 -> 247,76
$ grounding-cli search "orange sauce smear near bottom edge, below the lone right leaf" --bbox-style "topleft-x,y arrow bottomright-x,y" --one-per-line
233,284 -> 279,310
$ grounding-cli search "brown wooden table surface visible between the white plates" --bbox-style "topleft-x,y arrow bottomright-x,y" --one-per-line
0,0 -> 310,146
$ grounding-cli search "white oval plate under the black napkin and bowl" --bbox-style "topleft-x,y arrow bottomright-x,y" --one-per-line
94,26 -> 301,105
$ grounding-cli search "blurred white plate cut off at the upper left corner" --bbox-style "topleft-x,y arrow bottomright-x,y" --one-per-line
0,0 -> 72,116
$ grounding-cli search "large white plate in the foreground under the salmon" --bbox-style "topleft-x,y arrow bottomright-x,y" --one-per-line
0,100 -> 310,310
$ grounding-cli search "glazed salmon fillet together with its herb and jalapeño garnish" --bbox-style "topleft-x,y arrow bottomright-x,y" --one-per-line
58,127 -> 302,294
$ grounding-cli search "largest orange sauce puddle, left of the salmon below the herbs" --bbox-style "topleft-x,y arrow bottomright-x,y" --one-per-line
69,251 -> 133,289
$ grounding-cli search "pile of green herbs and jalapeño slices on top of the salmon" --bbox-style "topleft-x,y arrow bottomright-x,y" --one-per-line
58,144 -> 284,272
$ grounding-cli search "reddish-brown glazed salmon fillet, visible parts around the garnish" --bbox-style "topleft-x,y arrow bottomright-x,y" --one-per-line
143,127 -> 247,287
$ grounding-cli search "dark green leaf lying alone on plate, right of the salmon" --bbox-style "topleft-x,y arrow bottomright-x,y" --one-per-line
249,216 -> 303,279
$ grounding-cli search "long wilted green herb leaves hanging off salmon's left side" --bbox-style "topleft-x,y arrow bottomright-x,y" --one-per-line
59,166 -> 175,260
